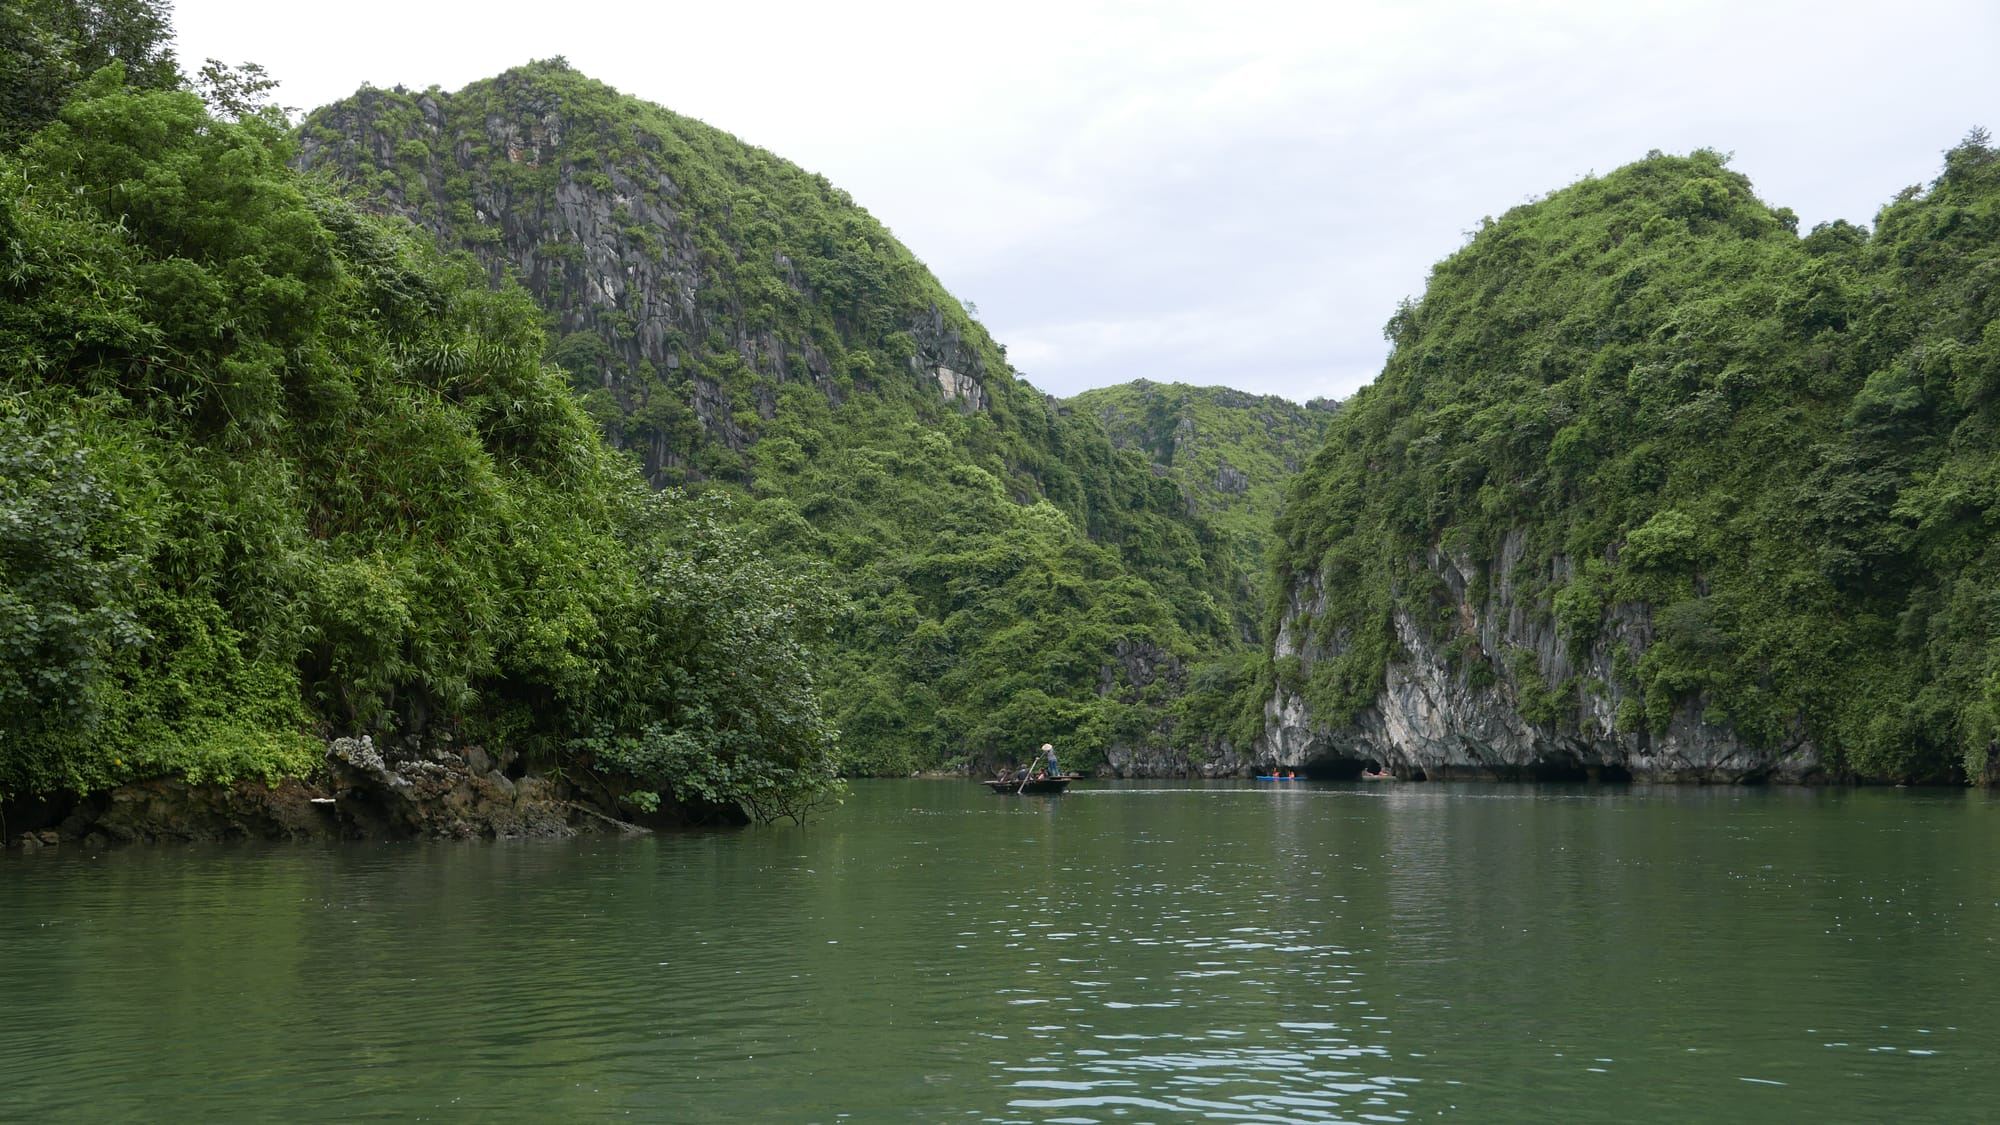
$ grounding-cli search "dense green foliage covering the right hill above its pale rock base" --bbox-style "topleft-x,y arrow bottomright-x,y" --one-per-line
1276,132 -> 2000,779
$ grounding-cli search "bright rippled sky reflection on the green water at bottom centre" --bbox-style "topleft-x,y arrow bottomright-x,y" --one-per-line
1000,871 -> 1414,1121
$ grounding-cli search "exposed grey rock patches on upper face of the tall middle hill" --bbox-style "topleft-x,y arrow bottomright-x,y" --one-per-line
296,78 -> 988,482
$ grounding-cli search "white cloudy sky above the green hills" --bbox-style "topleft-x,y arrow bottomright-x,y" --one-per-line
174,0 -> 2000,400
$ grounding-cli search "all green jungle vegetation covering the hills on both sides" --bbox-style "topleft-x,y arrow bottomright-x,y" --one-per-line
11,0 -> 2000,800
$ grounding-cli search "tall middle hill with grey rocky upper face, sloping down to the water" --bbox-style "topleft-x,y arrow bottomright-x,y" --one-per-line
302,60 -> 1254,773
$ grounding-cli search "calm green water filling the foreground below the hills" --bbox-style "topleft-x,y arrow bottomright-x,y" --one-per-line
0,781 -> 2000,1123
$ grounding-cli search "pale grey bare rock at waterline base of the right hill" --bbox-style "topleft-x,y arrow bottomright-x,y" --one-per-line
1254,534 -> 1828,783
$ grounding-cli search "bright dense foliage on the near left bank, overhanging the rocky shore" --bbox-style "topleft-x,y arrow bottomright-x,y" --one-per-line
0,66 -> 834,813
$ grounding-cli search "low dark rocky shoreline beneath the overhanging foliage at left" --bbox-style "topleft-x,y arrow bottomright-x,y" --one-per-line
0,737 -> 748,849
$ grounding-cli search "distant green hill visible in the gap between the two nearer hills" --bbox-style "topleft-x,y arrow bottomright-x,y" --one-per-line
1062,378 -> 1340,607
